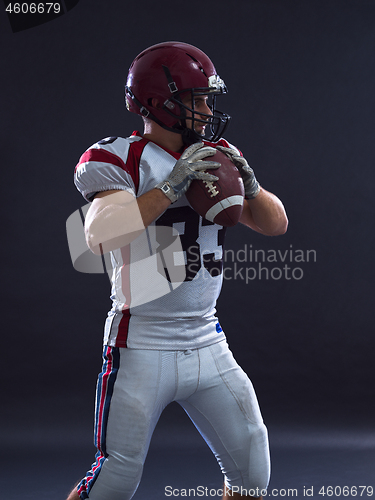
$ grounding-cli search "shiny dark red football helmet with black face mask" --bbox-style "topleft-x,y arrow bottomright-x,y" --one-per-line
125,42 -> 230,144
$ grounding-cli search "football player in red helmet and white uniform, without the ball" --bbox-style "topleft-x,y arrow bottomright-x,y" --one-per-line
68,42 -> 288,500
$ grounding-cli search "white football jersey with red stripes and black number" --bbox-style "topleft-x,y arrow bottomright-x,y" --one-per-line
75,132 -> 235,350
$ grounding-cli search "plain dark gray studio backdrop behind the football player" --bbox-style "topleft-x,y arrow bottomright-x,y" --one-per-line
0,0 -> 375,500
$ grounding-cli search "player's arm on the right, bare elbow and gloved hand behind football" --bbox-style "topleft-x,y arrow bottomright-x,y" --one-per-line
217,146 -> 288,236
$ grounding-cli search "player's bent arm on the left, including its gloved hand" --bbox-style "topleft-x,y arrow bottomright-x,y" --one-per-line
85,144 -> 220,255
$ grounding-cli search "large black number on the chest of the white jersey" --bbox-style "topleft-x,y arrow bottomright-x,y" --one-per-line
155,207 -> 226,283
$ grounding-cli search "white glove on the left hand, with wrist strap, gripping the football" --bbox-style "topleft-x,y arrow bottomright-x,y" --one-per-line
155,142 -> 220,203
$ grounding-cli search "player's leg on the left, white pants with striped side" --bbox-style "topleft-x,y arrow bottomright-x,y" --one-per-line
73,347 -> 174,500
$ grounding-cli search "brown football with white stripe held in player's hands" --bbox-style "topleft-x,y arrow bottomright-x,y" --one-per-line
186,150 -> 245,227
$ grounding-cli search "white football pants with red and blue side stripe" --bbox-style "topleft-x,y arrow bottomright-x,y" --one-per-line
78,341 -> 270,500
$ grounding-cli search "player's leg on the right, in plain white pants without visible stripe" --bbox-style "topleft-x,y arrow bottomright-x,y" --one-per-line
178,342 -> 270,498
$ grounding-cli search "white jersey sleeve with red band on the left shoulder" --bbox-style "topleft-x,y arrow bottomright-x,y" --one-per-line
74,137 -> 138,202
